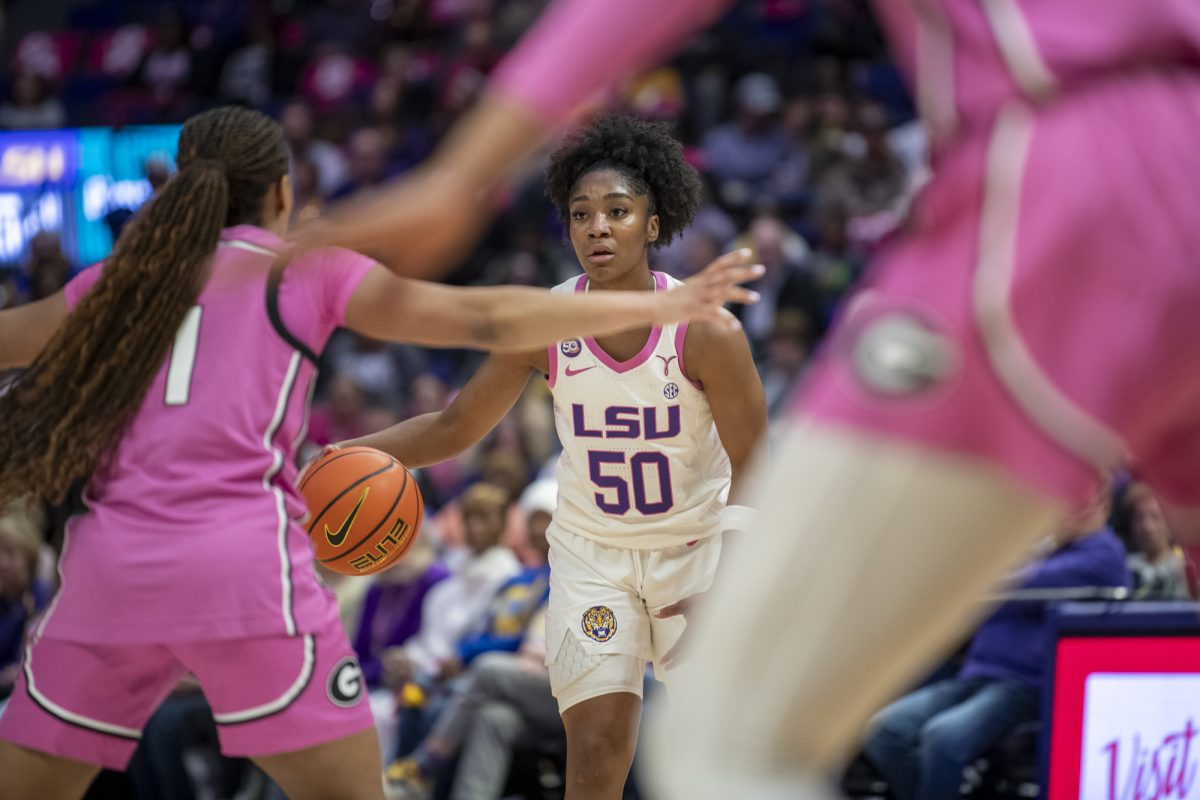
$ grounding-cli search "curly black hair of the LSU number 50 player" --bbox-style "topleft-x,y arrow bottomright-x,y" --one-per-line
546,116 -> 702,246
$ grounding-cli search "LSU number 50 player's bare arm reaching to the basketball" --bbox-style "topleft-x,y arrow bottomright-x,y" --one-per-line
340,354 -> 533,468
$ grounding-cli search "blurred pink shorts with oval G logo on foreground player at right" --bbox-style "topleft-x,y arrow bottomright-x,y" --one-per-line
797,71 -> 1200,507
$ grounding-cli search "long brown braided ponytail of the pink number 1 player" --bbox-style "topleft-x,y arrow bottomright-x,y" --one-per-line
0,107 -> 288,504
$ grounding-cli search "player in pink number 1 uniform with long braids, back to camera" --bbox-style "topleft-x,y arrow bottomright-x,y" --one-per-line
0,108 -> 758,799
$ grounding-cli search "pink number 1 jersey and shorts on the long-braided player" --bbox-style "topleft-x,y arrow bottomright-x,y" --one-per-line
0,225 -> 372,769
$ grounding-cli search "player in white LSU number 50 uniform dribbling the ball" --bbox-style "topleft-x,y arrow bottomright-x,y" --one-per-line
343,118 -> 767,800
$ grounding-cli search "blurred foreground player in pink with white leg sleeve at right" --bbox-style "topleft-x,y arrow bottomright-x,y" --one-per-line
292,0 -> 1200,800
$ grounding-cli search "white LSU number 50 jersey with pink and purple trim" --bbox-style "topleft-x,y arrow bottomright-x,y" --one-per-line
547,272 -> 731,549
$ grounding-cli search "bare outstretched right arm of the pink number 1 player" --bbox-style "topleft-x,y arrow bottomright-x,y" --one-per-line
346,251 -> 762,353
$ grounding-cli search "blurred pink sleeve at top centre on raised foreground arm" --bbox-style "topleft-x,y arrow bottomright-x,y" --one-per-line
492,0 -> 731,122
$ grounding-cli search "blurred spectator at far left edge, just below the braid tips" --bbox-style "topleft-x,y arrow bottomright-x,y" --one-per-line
0,509 -> 53,710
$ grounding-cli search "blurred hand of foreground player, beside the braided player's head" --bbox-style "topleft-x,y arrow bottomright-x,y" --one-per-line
289,163 -> 488,278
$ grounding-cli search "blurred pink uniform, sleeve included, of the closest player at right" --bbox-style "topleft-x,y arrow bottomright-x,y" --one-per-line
496,0 -> 1200,506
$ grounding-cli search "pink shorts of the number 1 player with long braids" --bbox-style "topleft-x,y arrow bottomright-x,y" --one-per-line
0,616 -> 373,770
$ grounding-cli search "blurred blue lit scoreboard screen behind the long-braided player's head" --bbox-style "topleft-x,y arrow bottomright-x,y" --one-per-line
0,125 -> 179,267
